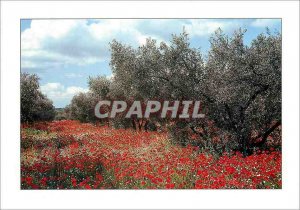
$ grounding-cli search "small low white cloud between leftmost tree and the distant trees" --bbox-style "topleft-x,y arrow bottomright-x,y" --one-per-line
40,83 -> 88,106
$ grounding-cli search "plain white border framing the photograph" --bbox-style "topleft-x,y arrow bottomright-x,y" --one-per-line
1,1 -> 299,209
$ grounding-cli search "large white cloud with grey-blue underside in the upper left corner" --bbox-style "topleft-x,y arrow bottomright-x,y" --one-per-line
21,20 -> 105,72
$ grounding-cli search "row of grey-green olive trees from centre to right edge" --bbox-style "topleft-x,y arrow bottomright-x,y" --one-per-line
68,29 -> 281,155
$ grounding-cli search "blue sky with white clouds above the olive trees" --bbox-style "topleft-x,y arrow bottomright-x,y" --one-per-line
21,19 -> 281,108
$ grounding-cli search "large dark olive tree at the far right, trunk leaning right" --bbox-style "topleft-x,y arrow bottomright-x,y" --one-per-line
202,30 -> 281,154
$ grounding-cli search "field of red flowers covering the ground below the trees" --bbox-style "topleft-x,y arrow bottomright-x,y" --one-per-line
21,120 -> 282,189
